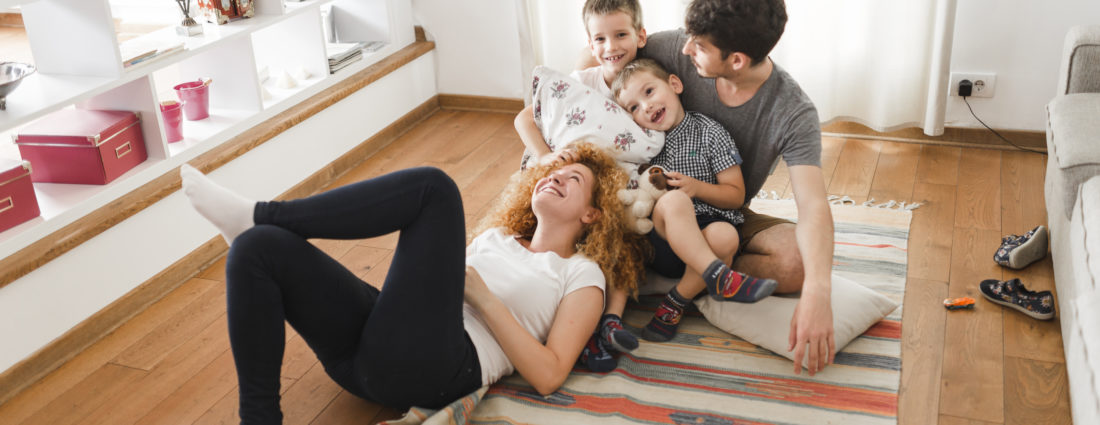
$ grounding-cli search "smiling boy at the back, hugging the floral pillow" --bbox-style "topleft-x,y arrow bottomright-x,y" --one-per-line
515,0 -> 646,168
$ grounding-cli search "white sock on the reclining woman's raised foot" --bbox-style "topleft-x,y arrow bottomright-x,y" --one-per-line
179,164 -> 256,244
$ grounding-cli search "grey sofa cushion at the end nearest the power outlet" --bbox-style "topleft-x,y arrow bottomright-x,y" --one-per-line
1046,94 -> 1100,219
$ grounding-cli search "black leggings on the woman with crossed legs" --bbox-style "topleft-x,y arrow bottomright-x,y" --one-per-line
226,167 -> 482,424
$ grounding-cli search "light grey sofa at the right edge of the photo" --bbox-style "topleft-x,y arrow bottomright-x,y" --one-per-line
1045,26 -> 1100,424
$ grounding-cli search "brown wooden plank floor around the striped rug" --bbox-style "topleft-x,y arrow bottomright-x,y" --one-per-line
0,110 -> 1070,425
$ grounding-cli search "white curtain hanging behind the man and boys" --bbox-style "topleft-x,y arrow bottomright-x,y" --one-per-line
516,0 -> 954,131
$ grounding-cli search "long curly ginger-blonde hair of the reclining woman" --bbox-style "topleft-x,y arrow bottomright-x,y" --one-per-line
471,140 -> 649,296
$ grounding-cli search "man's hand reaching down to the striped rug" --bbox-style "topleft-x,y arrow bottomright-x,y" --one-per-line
787,285 -> 836,377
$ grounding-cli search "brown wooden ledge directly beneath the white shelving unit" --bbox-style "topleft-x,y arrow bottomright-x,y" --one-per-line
0,41 -> 436,287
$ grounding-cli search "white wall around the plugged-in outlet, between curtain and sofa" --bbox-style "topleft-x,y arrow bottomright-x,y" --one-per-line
946,0 -> 1100,131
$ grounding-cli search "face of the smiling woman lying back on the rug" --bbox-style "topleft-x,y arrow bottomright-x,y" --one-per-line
531,163 -> 600,224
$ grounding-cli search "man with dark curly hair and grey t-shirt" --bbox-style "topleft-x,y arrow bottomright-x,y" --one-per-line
639,0 -> 836,375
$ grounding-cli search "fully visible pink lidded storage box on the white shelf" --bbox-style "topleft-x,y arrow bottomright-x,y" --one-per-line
15,109 -> 147,185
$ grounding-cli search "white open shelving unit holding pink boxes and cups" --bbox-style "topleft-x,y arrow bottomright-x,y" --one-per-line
0,0 -> 414,258
